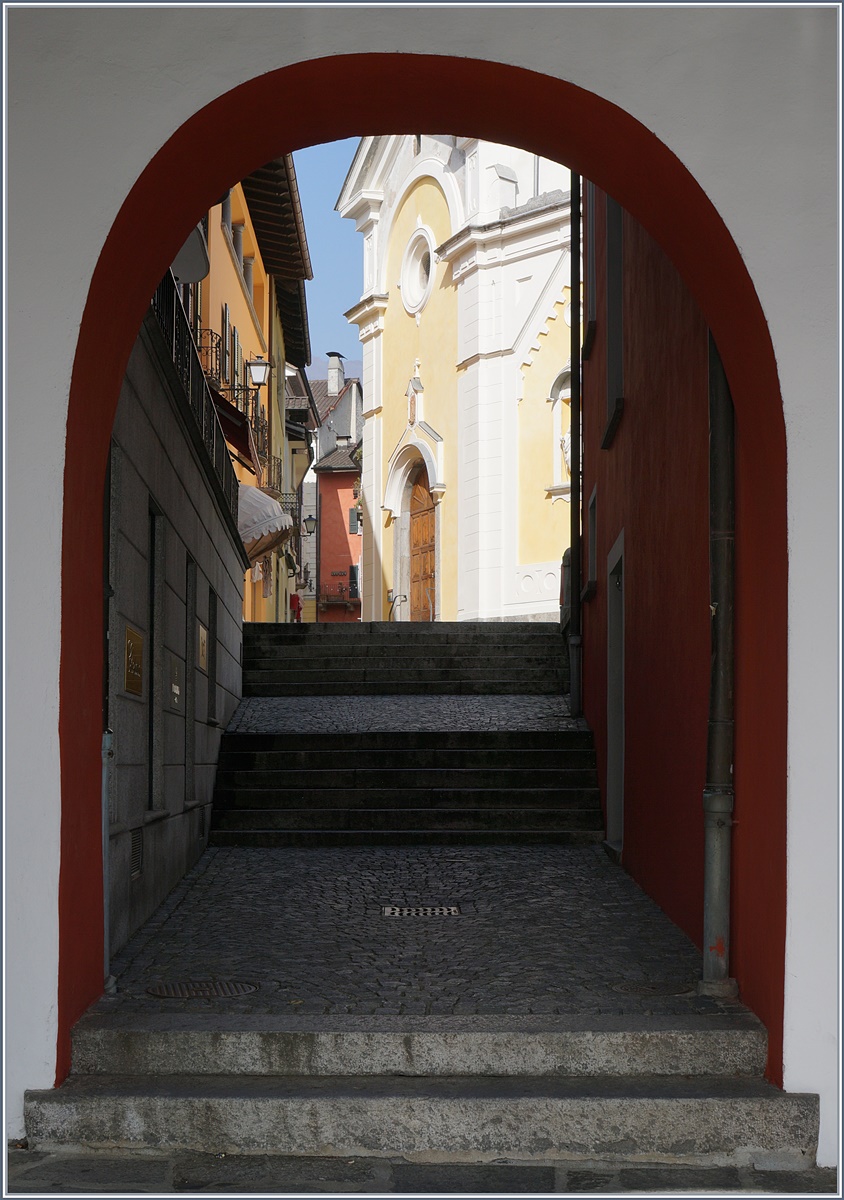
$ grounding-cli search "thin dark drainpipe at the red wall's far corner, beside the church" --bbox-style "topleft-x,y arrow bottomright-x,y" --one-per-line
569,172 -> 583,716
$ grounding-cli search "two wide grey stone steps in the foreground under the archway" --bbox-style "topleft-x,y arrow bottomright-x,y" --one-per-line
26,1013 -> 818,1170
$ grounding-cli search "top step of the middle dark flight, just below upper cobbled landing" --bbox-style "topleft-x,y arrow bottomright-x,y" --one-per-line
221,728 -> 594,754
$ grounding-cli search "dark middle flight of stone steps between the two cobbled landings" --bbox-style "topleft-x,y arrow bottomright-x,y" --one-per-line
210,730 -> 603,846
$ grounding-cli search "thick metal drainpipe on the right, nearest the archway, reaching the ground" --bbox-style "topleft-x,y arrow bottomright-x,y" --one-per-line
698,334 -> 738,996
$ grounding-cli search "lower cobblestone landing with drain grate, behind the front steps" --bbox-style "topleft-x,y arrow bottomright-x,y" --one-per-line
95,846 -> 744,1016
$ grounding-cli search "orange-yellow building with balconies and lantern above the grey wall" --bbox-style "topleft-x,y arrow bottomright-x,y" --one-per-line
186,155 -> 312,622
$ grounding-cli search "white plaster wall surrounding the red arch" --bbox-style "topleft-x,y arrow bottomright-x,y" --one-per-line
6,5 -> 839,1163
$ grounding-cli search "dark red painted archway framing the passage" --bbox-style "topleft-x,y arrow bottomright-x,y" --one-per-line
56,54 -> 788,1081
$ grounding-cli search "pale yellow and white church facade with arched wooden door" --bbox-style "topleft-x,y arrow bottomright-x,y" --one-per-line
337,136 -> 571,620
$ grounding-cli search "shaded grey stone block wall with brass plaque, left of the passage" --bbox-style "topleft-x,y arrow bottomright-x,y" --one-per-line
104,324 -> 244,953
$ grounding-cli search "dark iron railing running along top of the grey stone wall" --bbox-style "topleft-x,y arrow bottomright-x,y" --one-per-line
152,271 -> 238,523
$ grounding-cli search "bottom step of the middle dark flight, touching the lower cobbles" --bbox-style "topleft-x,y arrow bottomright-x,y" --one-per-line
209,829 -> 605,850
